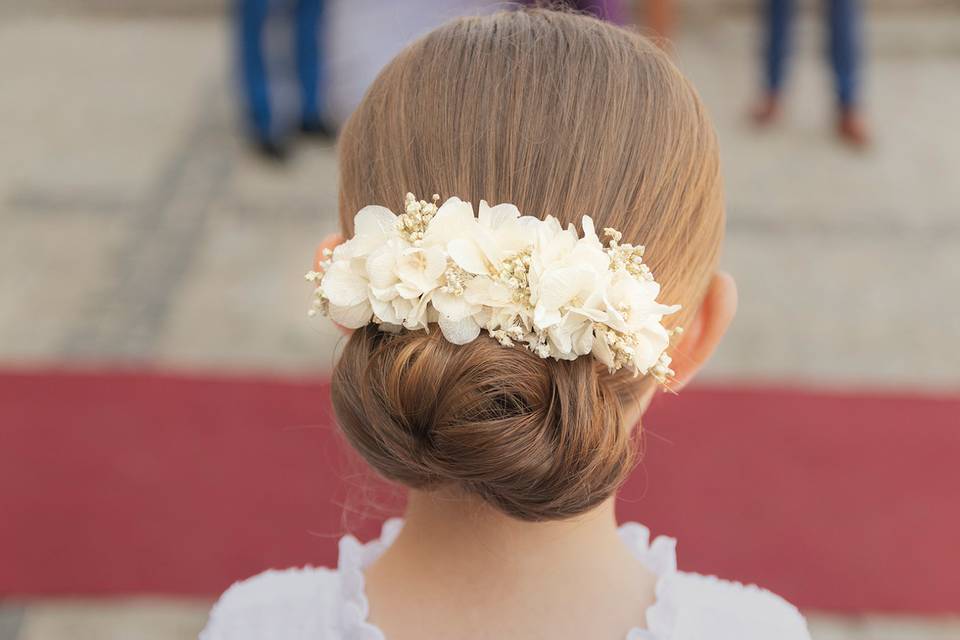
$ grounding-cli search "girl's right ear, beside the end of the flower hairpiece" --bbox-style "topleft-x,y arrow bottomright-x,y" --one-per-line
670,271 -> 737,391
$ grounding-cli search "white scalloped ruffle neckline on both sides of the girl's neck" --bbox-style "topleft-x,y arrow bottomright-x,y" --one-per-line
337,518 -> 677,640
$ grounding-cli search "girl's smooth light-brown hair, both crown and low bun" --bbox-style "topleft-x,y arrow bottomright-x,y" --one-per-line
333,9 -> 724,520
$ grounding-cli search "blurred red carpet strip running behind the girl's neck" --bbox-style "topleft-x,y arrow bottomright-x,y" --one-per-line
0,371 -> 960,613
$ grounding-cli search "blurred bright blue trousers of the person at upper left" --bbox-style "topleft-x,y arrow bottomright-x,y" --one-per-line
234,0 -> 324,140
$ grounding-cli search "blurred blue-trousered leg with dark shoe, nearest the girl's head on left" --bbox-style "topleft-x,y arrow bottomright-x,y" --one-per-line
295,0 -> 330,135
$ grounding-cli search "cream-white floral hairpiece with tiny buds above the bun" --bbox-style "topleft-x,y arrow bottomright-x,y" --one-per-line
306,193 -> 680,384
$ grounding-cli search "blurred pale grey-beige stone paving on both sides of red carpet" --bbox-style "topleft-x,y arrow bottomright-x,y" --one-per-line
0,6 -> 960,640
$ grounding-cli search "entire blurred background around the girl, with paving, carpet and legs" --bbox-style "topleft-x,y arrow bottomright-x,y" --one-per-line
0,0 -> 960,640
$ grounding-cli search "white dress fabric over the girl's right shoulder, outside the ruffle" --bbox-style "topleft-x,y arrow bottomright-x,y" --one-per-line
647,572 -> 810,640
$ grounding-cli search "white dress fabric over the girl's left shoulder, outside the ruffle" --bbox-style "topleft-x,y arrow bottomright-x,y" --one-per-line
200,567 -> 339,640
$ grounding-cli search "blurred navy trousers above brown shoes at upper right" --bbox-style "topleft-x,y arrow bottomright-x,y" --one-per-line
765,0 -> 860,107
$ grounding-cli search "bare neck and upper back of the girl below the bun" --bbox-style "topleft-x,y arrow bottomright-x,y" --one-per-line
366,492 -> 656,637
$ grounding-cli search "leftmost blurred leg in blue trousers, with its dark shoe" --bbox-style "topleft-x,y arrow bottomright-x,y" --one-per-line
234,0 -> 284,157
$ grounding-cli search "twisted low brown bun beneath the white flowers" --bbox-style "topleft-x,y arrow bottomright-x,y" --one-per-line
332,326 -> 633,521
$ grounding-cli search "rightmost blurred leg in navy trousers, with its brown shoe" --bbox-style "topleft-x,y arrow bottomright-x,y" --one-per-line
826,0 -> 867,145
